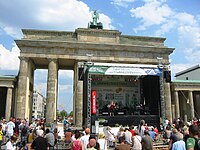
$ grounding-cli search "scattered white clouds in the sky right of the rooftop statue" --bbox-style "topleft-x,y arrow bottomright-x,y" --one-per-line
130,0 -> 200,72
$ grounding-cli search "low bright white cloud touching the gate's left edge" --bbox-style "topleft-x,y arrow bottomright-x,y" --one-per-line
0,44 -> 20,70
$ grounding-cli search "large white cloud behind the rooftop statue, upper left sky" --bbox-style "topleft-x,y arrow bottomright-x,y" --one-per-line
0,0 -> 112,37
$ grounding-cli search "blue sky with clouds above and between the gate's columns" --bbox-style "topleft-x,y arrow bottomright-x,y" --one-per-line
0,0 -> 200,112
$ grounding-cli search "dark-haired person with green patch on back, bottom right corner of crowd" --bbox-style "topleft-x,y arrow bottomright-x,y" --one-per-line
186,124 -> 200,150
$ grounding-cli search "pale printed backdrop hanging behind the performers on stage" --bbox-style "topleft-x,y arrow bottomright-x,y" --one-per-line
92,75 -> 140,109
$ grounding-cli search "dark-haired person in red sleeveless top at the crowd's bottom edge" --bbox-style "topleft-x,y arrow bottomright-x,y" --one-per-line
72,130 -> 84,150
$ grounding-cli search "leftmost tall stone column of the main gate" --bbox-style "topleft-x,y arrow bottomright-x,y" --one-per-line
15,57 -> 29,118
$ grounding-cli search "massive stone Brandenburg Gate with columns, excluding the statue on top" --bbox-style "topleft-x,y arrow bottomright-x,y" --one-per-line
15,28 -> 174,126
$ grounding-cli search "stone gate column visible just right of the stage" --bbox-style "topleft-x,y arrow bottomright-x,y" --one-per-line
164,82 -> 172,121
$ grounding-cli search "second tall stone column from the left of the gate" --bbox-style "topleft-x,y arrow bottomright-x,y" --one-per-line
46,59 -> 58,123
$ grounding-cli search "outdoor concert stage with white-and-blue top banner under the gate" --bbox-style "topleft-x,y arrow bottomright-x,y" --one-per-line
83,63 -> 161,127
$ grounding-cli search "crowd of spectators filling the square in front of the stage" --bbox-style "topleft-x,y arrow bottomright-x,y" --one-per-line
0,118 -> 200,150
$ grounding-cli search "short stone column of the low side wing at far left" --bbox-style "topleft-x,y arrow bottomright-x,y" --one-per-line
5,87 -> 13,120
